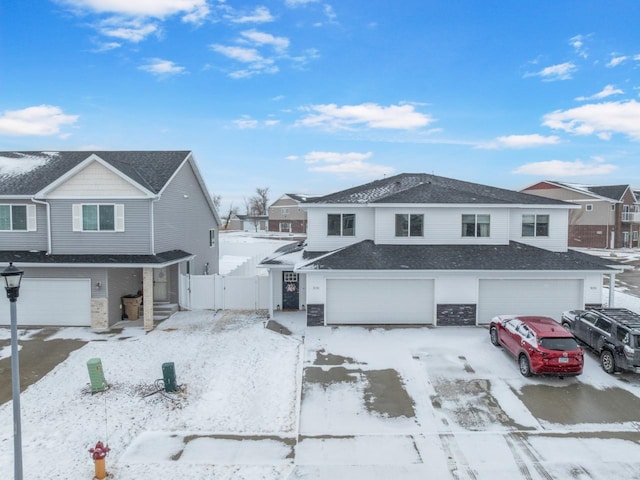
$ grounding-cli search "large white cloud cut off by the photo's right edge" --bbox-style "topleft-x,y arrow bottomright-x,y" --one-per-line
543,100 -> 640,140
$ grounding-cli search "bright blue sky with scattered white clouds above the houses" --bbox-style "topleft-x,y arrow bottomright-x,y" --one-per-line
0,0 -> 640,211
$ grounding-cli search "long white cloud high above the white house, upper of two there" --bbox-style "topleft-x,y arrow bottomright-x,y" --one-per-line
297,103 -> 434,130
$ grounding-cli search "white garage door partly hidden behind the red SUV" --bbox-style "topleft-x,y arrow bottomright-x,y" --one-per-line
478,280 -> 584,324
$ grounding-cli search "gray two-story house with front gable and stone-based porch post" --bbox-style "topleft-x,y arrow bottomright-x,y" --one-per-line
0,151 -> 220,330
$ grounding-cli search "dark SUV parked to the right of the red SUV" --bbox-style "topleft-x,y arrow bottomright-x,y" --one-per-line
562,308 -> 640,373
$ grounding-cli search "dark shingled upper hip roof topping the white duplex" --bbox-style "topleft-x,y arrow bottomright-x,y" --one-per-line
305,173 -> 570,205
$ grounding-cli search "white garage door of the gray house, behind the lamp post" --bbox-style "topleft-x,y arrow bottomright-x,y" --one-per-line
0,278 -> 91,326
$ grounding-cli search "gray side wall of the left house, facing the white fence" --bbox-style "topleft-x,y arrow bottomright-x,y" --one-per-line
153,162 -> 219,274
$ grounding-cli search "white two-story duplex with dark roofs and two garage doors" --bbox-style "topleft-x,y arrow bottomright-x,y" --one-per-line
261,174 -> 620,325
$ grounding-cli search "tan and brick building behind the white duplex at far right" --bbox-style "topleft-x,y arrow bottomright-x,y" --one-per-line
521,180 -> 640,248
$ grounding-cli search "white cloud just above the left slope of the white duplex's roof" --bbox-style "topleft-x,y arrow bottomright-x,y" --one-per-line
296,151 -> 395,178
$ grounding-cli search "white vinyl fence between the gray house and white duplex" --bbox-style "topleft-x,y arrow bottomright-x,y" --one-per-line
180,275 -> 269,310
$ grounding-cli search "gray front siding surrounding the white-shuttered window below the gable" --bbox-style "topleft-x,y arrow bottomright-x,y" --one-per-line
51,198 -> 152,255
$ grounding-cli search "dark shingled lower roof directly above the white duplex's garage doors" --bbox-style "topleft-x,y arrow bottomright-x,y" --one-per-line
299,240 -> 616,271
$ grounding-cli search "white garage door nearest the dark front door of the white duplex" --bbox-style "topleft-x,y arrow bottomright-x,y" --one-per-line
325,279 -> 433,325
